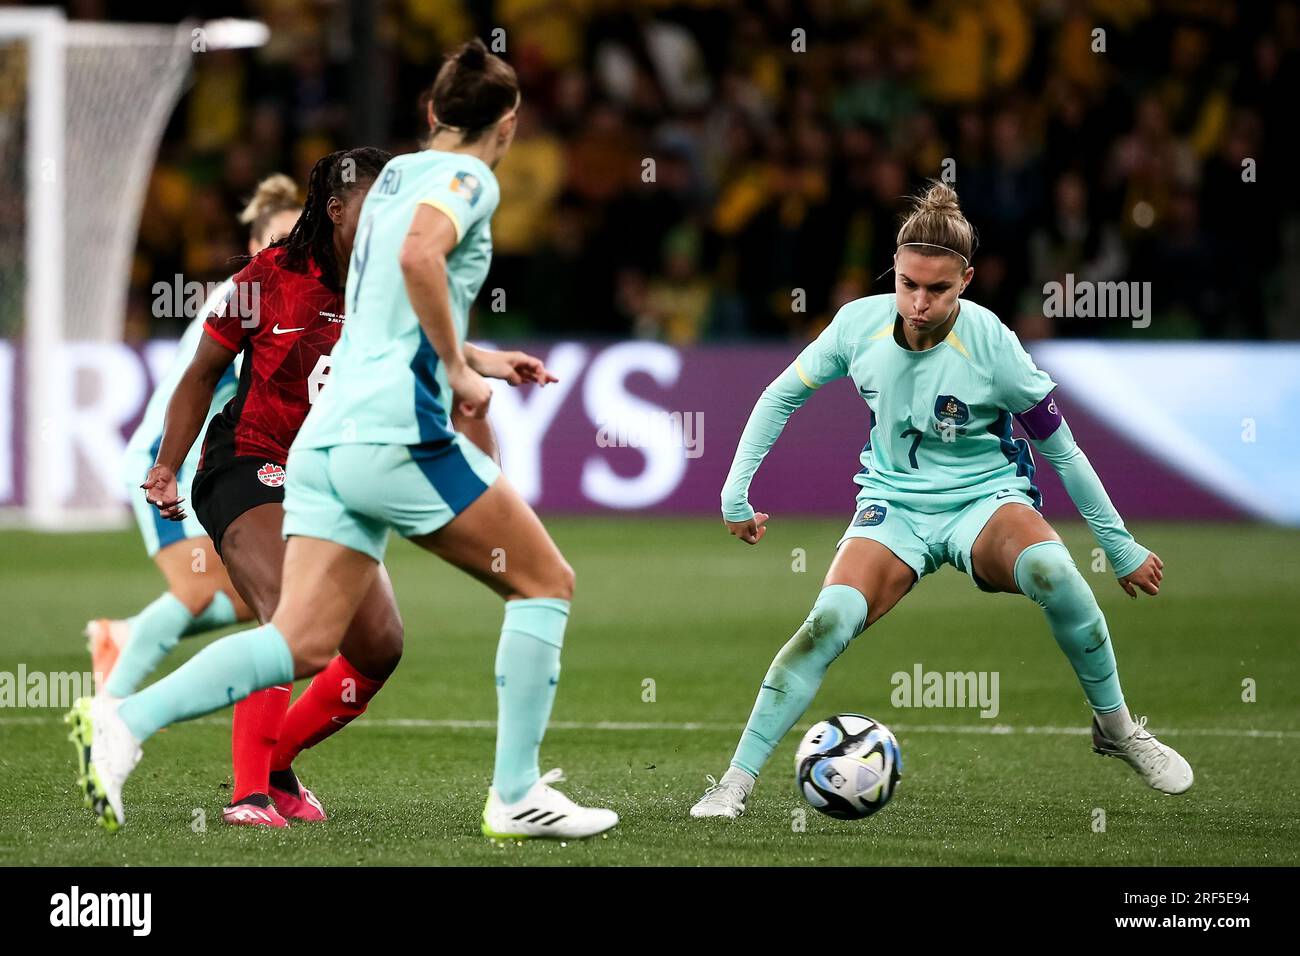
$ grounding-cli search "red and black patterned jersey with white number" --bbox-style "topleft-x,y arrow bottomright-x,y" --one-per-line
199,247 -> 343,468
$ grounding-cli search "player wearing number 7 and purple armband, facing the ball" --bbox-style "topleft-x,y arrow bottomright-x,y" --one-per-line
690,182 -> 1192,817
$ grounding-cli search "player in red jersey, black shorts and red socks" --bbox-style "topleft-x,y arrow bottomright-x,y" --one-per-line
76,147 -> 402,827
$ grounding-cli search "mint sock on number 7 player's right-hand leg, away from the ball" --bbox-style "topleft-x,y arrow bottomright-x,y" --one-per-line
1013,541 -> 1125,714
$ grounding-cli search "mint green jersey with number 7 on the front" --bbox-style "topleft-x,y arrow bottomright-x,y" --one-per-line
796,294 -> 1056,514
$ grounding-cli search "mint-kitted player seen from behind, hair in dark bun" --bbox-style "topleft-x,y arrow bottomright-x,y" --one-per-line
72,40 -> 619,839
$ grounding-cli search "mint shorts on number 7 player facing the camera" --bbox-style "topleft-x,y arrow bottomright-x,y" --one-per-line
836,490 -> 1034,591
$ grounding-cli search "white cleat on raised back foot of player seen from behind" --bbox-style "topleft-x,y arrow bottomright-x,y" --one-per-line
65,695 -> 142,832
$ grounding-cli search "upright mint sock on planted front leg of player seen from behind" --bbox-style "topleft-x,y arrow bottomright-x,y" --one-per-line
493,597 -> 569,804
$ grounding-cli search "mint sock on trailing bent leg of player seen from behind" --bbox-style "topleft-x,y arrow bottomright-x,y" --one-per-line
118,624 -> 294,741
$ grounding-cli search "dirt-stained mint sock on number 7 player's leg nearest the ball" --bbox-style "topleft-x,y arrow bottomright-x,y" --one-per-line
731,584 -> 867,777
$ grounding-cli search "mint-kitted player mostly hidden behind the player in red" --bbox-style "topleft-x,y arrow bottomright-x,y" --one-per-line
86,173 -> 302,697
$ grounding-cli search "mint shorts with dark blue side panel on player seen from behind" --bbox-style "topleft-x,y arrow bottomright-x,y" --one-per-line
283,433 -> 501,561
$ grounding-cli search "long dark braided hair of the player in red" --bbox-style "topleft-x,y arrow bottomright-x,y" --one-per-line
272,146 -> 393,291
